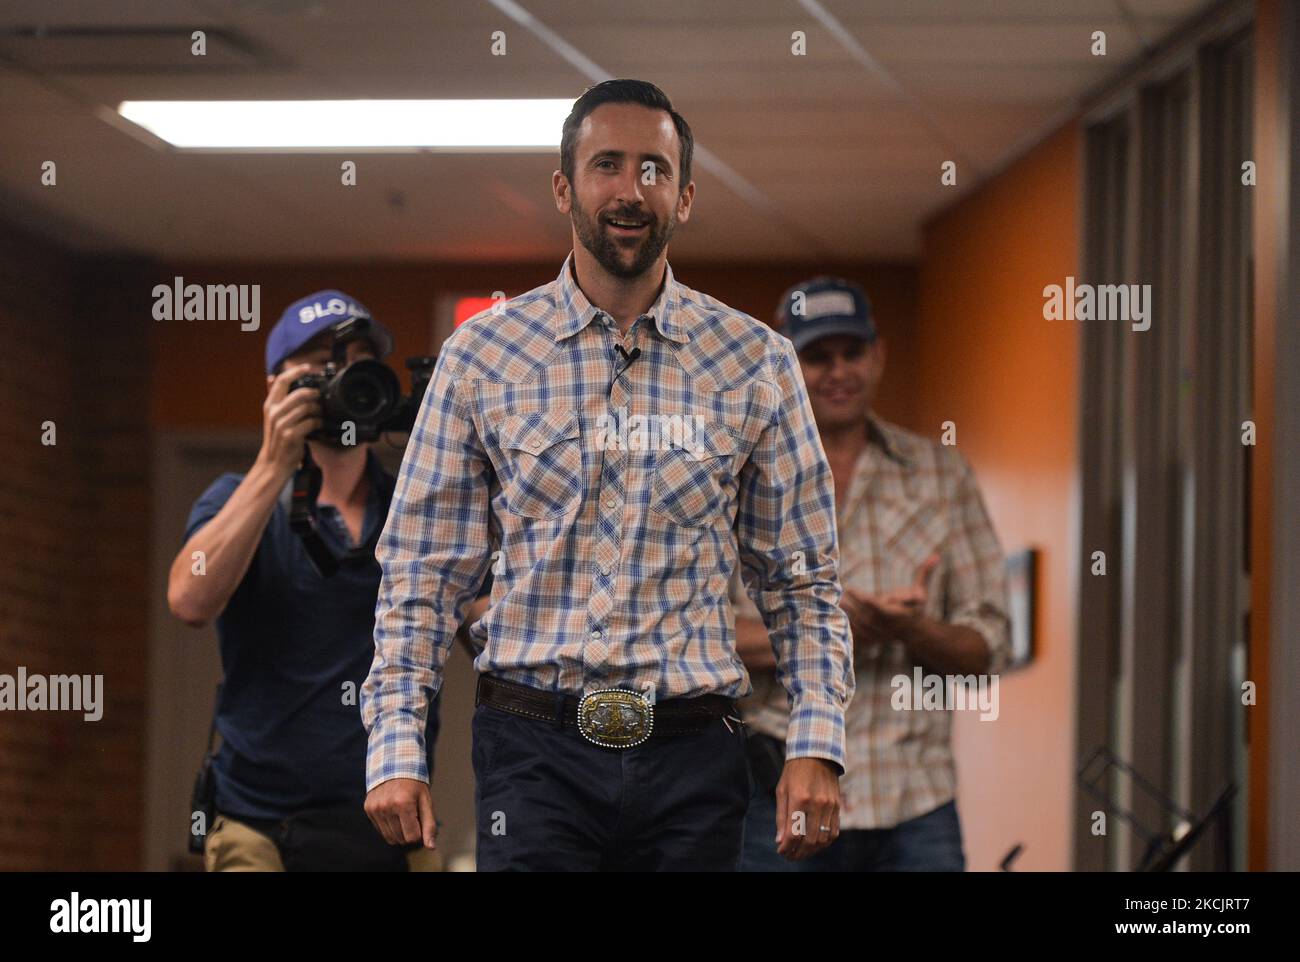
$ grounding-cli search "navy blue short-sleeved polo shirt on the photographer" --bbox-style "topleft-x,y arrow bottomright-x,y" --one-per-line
185,451 -> 438,819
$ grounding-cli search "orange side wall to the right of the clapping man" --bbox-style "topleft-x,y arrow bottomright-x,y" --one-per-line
904,124 -> 1082,870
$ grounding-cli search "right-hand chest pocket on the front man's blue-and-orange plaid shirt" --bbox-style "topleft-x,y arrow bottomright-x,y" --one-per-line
651,421 -> 736,528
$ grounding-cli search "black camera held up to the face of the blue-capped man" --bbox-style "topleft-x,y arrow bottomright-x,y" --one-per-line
289,317 -> 437,445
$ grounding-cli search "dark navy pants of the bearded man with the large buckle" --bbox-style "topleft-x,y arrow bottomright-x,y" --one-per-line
473,705 -> 751,872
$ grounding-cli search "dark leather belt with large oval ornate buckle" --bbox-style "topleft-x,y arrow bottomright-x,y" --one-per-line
475,675 -> 736,748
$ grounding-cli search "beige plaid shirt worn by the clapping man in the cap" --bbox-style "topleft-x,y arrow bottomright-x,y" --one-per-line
731,417 -> 1010,828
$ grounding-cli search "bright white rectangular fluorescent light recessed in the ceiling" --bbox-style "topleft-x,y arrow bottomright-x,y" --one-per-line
117,99 -> 573,151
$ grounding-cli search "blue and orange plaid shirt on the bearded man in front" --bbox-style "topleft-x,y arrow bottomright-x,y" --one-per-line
361,254 -> 854,790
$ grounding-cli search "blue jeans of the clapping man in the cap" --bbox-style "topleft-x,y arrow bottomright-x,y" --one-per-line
741,793 -> 966,872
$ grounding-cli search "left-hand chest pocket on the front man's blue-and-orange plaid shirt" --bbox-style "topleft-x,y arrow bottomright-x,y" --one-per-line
499,410 -> 582,517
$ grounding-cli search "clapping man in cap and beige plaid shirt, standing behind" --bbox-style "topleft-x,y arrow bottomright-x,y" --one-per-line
732,278 -> 1010,871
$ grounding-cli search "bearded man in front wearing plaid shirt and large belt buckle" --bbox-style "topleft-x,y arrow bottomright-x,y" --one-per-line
361,81 -> 853,871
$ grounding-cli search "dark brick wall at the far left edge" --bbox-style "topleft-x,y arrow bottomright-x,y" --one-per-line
0,229 -> 150,870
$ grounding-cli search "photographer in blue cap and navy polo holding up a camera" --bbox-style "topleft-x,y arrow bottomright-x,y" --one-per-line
168,291 -> 478,871
